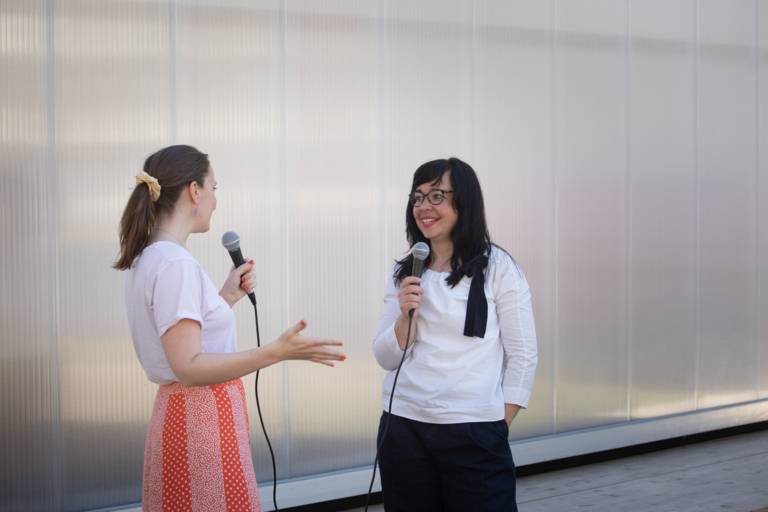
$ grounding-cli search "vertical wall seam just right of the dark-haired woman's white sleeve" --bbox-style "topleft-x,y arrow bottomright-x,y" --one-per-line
549,0 -> 560,434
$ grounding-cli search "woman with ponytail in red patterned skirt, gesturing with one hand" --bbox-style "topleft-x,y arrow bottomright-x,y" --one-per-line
114,145 -> 345,511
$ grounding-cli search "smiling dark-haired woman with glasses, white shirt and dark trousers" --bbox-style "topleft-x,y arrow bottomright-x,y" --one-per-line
373,158 -> 537,512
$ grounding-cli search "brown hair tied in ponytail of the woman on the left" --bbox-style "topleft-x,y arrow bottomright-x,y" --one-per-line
112,145 -> 210,270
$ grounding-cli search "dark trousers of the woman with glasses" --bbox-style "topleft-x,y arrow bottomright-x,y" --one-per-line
377,412 -> 517,512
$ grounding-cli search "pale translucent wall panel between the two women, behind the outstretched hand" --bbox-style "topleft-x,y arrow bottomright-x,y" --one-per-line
285,0 -> 384,478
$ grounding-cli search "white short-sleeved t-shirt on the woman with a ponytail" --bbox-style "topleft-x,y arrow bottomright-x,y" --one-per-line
125,241 -> 237,384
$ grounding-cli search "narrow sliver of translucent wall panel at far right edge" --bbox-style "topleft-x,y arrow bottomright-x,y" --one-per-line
755,0 -> 768,398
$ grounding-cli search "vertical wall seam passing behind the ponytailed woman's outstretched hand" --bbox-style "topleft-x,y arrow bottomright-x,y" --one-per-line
278,0 -> 292,475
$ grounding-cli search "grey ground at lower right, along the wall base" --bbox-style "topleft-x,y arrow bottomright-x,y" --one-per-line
350,431 -> 768,512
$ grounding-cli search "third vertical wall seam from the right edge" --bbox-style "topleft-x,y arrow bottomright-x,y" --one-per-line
624,0 -> 634,421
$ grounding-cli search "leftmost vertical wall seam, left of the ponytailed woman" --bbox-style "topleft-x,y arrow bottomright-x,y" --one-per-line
45,0 -> 64,510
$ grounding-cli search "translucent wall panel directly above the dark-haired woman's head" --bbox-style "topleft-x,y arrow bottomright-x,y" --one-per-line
381,0 -> 473,262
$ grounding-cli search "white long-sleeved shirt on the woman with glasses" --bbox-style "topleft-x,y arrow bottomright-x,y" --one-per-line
373,247 -> 538,423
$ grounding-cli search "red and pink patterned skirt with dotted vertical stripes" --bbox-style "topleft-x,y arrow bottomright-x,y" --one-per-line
143,380 -> 261,512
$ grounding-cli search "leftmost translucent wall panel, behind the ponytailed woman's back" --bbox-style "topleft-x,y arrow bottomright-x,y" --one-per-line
0,1 -> 61,510
